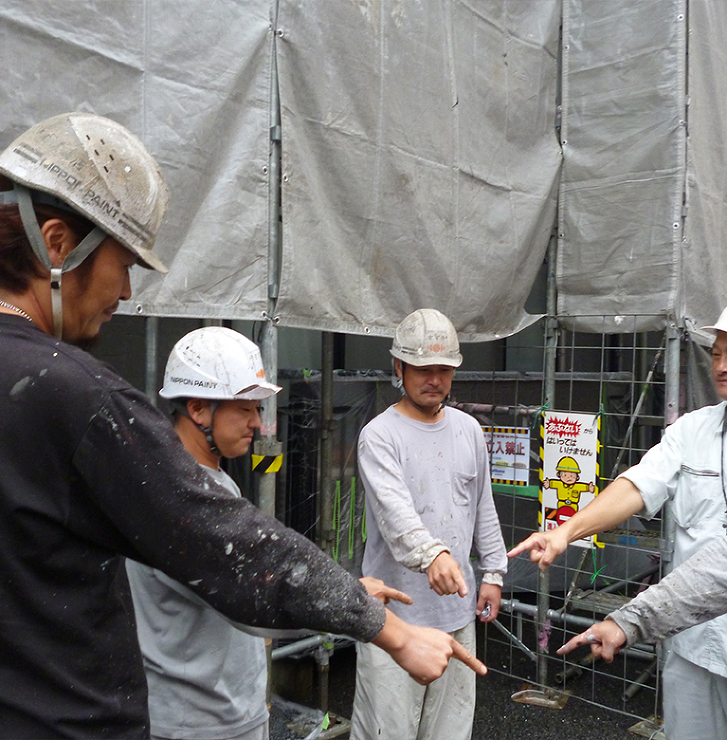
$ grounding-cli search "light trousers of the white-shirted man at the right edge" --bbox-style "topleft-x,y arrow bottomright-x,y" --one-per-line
662,651 -> 727,740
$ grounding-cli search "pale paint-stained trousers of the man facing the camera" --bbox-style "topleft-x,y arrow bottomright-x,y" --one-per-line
350,621 -> 476,740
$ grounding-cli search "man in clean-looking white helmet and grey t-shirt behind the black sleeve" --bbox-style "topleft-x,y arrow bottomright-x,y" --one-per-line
126,326 -> 280,740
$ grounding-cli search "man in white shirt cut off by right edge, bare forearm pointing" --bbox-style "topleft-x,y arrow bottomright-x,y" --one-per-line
510,309 -> 727,740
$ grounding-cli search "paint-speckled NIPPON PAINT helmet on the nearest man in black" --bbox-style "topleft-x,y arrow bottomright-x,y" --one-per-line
0,113 -> 169,272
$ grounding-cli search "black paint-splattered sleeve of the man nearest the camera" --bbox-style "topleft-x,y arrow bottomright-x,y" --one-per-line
73,390 -> 385,641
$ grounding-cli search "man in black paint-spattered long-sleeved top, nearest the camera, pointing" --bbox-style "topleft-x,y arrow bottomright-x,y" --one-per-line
0,113 -> 485,738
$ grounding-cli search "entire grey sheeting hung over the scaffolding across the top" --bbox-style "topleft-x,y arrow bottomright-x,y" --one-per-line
0,0 -> 727,340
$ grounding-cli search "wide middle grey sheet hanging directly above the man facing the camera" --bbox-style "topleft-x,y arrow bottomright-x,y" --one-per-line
277,0 -> 560,339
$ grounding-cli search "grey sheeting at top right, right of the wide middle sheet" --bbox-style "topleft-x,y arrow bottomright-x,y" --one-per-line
557,0 -> 727,332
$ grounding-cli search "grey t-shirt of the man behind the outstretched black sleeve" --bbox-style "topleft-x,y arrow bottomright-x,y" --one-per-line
126,467 -> 268,740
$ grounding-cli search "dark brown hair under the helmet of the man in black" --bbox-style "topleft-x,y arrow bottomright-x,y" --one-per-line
0,195 -> 95,293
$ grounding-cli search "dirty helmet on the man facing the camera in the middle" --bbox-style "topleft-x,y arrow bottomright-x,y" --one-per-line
390,308 -> 462,367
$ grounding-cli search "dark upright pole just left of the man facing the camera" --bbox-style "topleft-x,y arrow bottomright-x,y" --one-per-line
318,331 -> 333,554
